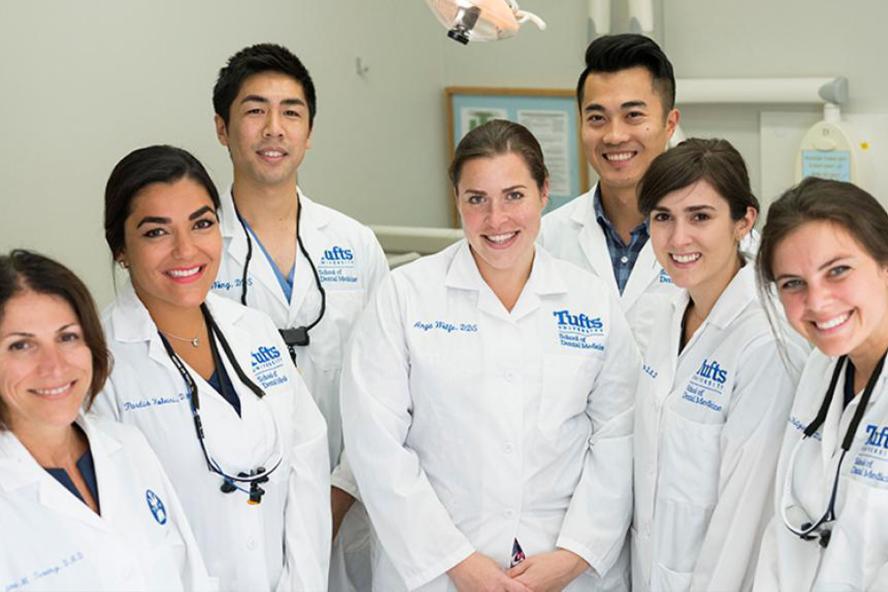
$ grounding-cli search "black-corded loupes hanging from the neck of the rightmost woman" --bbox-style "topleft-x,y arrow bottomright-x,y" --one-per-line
780,352 -> 888,548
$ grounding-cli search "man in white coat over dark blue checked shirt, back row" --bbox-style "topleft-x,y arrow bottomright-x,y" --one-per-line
539,34 -> 679,353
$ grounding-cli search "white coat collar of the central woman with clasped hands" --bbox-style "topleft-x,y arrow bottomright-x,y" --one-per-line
444,239 -> 567,321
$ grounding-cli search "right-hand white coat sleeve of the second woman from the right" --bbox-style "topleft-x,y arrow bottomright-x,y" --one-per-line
691,338 -> 801,590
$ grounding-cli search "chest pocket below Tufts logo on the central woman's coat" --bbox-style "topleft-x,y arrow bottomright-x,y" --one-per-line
538,353 -> 601,438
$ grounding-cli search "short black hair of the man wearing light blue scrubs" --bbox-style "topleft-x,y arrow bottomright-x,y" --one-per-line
213,43 -> 317,129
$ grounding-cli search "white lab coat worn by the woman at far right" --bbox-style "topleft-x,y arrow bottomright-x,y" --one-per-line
755,351 -> 888,592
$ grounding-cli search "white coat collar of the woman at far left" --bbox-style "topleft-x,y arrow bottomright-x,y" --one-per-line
0,414 -> 122,530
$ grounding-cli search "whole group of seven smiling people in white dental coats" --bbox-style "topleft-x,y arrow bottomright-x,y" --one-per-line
0,35 -> 888,592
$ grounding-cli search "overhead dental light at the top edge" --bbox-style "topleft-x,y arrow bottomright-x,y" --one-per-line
426,0 -> 546,45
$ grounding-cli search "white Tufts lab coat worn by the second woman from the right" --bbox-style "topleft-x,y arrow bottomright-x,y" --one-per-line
632,264 -> 805,592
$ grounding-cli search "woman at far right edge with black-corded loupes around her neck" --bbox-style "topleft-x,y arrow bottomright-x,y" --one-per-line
755,178 -> 888,592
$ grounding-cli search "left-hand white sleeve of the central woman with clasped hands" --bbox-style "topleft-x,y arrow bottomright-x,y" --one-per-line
341,276 -> 474,590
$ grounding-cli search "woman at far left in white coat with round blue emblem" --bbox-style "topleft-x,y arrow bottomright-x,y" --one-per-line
0,251 -> 215,591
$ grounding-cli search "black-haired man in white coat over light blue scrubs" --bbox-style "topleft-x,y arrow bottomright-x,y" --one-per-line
213,43 -> 388,592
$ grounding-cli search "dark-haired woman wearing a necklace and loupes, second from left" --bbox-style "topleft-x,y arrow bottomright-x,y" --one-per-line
96,146 -> 330,591
